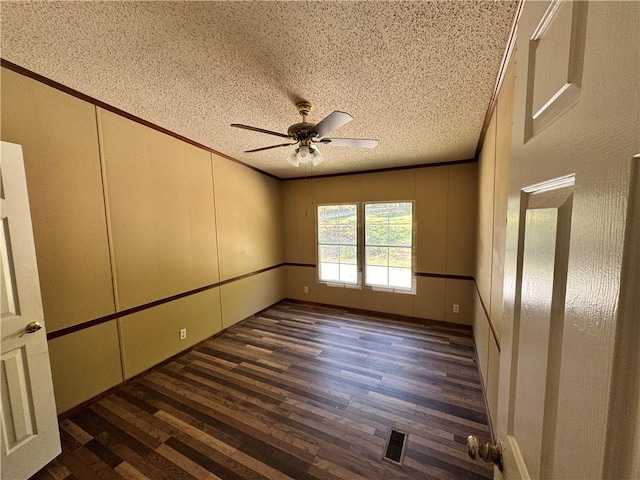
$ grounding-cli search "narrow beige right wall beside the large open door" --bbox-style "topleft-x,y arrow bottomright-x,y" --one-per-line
473,58 -> 514,430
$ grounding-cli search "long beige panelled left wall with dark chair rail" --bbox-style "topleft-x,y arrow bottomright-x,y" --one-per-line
1,68 -> 285,412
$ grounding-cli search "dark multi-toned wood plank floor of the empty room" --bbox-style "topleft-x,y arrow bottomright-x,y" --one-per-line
33,301 -> 492,480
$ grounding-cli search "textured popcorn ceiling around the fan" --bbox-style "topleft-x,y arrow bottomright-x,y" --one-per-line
1,0 -> 516,178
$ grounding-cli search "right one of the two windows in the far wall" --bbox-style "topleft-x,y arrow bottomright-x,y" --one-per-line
364,202 -> 413,289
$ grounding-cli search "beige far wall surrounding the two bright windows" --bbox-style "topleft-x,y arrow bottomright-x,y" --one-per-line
284,163 -> 477,324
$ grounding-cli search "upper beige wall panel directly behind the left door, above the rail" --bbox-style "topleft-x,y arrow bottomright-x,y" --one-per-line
0,68 -> 115,331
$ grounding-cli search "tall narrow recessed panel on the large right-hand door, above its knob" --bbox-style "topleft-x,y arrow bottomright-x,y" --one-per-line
504,176 -> 575,478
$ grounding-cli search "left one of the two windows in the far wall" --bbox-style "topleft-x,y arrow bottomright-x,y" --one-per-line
317,204 -> 358,285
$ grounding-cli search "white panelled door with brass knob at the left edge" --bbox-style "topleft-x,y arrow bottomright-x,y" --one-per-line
0,142 -> 61,480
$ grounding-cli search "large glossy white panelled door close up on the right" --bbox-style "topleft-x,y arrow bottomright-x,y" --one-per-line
496,1 -> 640,480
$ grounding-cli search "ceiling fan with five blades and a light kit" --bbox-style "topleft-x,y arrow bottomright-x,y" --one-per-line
231,102 -> 378,167
